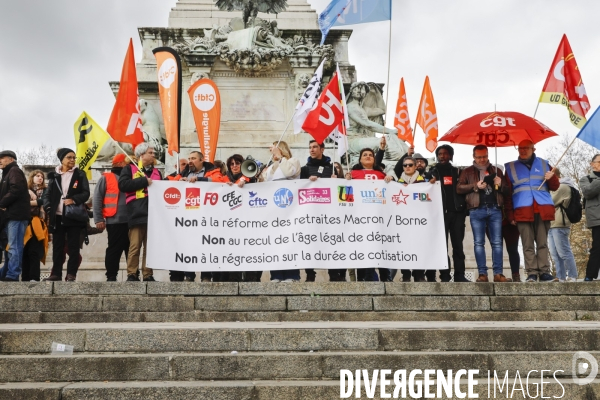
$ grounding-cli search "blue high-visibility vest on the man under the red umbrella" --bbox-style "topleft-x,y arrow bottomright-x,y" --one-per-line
504,157 -> 554,208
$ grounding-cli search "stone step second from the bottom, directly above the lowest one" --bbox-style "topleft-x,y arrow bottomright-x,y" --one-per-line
0,351 -> 600,382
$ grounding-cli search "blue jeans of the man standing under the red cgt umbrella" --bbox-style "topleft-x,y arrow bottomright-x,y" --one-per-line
469,206 -> 503,275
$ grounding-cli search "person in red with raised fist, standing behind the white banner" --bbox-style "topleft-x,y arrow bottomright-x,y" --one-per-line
346,141 -> 394,282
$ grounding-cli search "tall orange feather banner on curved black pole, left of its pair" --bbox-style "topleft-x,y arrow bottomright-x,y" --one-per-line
152,47 -> 181,155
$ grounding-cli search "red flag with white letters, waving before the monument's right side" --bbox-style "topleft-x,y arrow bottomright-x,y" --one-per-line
302,74 -> 344,144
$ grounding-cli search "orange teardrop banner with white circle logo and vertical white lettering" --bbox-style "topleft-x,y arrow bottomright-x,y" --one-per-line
188,79 -> 221,162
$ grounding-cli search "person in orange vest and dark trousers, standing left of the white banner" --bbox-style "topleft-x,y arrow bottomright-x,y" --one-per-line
92,154 -> 129,282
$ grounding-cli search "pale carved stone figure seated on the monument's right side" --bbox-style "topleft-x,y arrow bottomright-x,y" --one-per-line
346,82 -> 408,169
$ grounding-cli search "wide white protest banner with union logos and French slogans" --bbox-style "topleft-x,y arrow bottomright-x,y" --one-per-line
147,179 -> 448,271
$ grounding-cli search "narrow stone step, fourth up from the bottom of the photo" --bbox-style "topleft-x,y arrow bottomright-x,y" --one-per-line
0,310 -> 580,324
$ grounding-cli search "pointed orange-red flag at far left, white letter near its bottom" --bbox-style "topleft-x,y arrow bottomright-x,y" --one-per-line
106,39 -> 144,147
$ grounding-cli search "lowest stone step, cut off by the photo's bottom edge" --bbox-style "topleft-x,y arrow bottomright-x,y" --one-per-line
0,379 -> 600,400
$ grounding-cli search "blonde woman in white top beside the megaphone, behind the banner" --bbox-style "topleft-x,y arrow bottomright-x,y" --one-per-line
260,141 -> 300,282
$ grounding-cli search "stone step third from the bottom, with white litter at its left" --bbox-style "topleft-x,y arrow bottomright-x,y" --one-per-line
0,321 -> 600,354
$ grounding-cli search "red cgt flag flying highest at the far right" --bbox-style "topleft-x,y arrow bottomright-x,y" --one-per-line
539,35 -> 590,129
